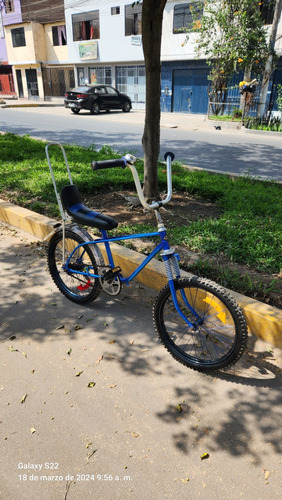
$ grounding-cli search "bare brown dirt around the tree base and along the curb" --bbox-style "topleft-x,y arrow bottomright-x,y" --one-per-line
83,191 -> 282,308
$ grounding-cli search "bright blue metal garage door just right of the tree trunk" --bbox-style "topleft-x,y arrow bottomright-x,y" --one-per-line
173,68 -> 209,114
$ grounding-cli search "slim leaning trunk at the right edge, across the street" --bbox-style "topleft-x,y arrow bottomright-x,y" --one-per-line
257,0 -> 282,118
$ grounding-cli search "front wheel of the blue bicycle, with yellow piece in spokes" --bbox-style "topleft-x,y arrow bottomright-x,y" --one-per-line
153,276 -> 248,371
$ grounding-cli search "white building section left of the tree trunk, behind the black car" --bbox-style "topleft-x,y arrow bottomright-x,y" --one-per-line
65,0 -> 145,108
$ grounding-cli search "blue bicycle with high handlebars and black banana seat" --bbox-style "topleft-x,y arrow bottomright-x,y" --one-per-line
46,143 -> 247,372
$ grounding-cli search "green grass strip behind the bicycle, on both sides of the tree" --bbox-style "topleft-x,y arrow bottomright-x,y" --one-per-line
0,134 -> 282,274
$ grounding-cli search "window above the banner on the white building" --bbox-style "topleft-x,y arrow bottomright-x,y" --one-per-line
72,10 -> 100,42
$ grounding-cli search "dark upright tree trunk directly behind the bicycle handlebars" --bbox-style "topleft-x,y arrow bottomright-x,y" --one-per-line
142,0 -> 166,201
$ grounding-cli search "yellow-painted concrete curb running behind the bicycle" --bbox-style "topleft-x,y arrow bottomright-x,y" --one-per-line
0,199 -> 282,348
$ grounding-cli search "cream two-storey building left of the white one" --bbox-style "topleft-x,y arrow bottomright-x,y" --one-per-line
4,0 -> 74,100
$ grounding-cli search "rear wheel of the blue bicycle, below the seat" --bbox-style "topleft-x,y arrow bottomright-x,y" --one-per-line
48,229 -> 101,304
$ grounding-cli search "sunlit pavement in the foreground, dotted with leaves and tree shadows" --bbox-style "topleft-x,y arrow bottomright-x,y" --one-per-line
0,225 -> 282,500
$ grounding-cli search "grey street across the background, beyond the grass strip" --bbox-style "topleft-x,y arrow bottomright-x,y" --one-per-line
0,107 -> 282,181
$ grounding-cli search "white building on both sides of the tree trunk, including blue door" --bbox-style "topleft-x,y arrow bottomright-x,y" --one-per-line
65,0 -> 208,111
